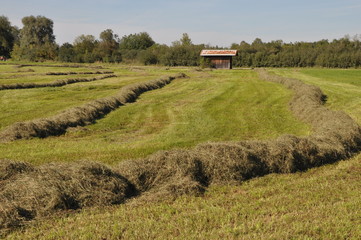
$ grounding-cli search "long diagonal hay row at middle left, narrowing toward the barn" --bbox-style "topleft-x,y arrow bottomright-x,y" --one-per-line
0,74 -> 185,142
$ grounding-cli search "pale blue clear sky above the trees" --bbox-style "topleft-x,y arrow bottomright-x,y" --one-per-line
0,0 -> 361,47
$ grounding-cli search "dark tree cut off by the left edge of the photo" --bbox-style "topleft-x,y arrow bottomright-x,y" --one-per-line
0,16 -> 16,58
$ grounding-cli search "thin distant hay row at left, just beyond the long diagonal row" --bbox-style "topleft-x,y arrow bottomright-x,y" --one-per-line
0,74 -> 117,90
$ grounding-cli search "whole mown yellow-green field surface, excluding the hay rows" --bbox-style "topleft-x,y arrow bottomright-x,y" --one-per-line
0,62 -> 361,239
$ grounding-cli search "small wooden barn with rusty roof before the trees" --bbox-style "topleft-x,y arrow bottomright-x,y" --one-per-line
201,50 -> 237,69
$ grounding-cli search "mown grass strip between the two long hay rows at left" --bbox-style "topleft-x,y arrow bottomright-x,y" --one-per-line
0,76 -> 161,130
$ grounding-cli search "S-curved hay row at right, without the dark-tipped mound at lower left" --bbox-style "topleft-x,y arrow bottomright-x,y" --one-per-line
117,70 -> 361,193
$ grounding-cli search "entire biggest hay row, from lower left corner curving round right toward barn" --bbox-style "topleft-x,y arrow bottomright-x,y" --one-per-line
0,70 -> 361,234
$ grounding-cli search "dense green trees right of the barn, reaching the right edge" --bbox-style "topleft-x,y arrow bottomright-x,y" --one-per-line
232,37 -> 361,68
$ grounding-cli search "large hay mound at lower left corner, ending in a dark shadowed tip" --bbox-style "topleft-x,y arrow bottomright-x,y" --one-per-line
0,161 -> 136,231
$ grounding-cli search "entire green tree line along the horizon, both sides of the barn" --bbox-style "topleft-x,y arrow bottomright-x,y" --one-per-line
0,16 -> 361,68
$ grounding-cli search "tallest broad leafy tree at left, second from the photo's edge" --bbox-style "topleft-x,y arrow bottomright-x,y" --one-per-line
12,16 -> 57,61
